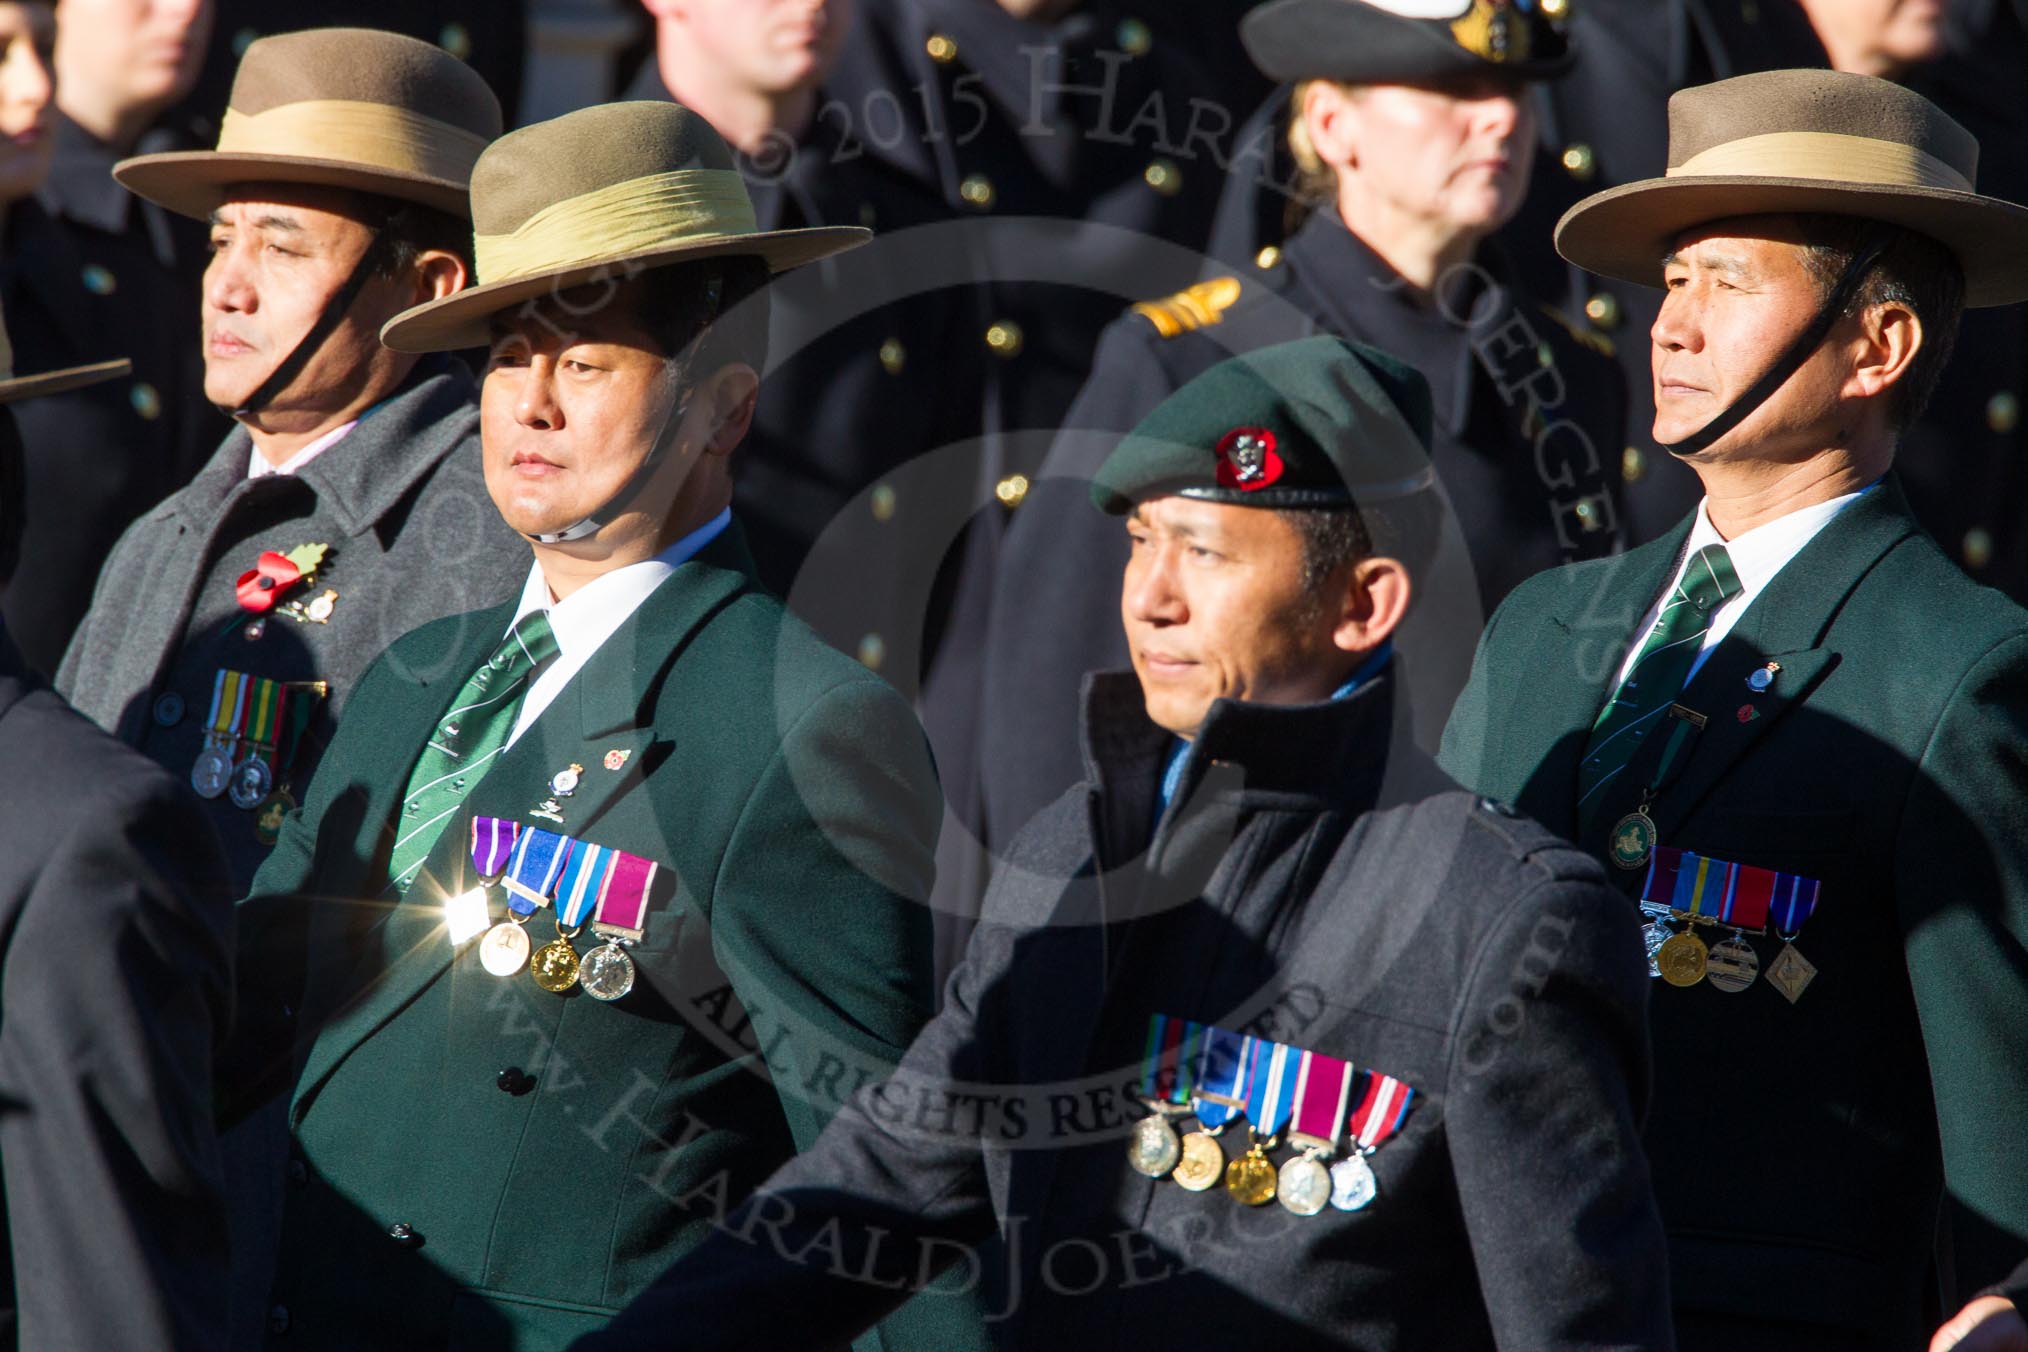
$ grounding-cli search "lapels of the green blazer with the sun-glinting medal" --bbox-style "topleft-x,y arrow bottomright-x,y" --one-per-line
292,523 -> 752,1121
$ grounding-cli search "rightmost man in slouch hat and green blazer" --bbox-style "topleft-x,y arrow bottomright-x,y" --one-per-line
1444,71 -> 2028,1352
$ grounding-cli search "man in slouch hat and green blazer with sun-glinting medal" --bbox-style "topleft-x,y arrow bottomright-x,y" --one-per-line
227,101 -> 969,1350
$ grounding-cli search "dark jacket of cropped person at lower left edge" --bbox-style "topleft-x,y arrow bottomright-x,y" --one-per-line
0,632 -> 233,1352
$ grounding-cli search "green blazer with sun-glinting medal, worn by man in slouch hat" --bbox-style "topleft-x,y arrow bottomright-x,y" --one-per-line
235,525 -> 981,1352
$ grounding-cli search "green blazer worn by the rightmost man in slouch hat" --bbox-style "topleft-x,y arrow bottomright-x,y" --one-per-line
1442,476 -> 2028,1348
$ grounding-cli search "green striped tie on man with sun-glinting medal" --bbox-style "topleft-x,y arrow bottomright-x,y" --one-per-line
387,610 -> 556,892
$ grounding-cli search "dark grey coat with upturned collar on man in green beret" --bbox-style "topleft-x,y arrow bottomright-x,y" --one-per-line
578,675 -> 1673,1352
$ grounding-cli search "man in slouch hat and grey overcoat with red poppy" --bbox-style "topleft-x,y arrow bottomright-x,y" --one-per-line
57,28 -> 523,888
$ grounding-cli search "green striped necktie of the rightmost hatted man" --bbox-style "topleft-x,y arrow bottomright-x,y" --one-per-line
1578,545 -> 1740,831
